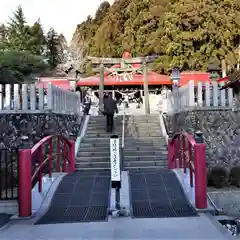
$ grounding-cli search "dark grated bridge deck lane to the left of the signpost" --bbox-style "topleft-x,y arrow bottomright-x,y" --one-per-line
36,171 -> 110,224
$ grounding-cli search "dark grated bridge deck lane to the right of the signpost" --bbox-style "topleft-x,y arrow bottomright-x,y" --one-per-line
129,169 -> 198,218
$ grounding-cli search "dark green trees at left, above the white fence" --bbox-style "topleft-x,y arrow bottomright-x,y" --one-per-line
0,6 -> 66,83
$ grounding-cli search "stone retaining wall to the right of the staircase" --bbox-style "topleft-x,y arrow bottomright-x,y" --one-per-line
166,109 -> 240,169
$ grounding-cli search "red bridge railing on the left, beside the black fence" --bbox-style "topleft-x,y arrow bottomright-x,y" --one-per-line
18,136 -> 75,217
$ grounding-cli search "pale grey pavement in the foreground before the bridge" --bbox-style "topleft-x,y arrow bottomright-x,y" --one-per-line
0,215 -> 230,240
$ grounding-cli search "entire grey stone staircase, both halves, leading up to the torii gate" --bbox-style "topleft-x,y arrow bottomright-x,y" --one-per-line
76,115 -> 168,170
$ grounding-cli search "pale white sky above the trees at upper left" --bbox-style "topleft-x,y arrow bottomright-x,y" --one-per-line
0,0 -> 107,42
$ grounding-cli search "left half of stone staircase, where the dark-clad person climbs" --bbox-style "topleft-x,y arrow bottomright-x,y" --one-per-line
76,116 -> 122,170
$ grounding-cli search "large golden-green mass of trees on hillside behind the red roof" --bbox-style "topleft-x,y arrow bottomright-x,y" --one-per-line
72,0 -> 240,72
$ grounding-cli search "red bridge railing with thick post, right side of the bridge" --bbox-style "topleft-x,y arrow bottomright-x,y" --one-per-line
168,132 -> 207,209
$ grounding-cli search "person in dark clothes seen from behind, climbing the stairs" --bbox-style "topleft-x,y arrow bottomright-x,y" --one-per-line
104,95 -> 118,132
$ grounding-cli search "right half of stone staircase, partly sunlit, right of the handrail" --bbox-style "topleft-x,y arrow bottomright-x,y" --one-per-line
124,115 -> 168,170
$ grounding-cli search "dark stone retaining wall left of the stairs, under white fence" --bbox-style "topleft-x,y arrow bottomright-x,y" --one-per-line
0,113 -> 81,149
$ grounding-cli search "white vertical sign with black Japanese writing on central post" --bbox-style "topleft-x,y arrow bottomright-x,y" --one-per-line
110,138 -> 121,181
